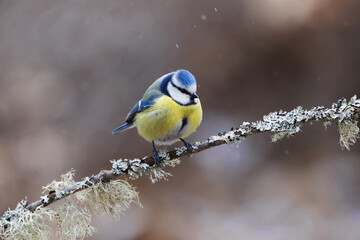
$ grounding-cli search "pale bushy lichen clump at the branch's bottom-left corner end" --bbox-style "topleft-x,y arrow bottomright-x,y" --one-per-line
0,201 -> 54,240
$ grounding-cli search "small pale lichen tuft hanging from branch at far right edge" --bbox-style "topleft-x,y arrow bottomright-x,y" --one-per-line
339,121 -> 360,150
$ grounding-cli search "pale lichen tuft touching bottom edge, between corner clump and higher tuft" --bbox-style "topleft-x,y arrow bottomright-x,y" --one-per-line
55,199 -> 97,240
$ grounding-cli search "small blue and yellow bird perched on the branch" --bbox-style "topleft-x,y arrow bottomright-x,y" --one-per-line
112,69 -> 202,164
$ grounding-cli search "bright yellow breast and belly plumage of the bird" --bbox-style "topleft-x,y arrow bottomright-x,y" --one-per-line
134,96 -> 202,142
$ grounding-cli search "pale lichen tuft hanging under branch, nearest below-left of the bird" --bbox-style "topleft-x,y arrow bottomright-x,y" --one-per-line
76,180 -> 141,218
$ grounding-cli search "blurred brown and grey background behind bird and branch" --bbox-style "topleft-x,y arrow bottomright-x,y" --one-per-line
0,0 -> 360,240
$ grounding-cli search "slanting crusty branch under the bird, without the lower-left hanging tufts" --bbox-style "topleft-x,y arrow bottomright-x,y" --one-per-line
5,95 -> 360,216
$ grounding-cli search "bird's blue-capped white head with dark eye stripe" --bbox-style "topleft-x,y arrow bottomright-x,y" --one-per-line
167,69 -> 199,105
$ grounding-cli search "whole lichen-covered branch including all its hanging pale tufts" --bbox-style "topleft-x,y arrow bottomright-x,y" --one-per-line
0,95 -> 360,240
